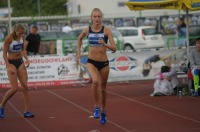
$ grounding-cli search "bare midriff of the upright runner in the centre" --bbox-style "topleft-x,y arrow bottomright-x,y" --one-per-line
88,46 -> 108,61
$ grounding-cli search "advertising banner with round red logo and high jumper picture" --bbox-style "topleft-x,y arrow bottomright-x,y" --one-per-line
108,49 -> 187,82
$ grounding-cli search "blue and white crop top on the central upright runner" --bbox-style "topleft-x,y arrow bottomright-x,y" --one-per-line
88,26 -> 108,46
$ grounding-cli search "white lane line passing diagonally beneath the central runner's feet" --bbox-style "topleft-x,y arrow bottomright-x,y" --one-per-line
46,90 -> 136,132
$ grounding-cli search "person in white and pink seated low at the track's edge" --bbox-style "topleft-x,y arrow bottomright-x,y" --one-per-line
151,66 -> 178,96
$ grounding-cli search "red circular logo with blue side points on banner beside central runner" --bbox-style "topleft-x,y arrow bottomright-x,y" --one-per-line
110,55 -> 138,71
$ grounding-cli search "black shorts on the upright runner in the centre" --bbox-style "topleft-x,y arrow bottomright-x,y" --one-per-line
87,58 -> 109,71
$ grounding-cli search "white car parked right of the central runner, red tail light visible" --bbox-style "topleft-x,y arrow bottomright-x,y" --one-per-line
117,26 -> 165,50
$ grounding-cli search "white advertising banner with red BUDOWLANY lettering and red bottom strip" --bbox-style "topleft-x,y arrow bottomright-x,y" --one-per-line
0,55 -> 89,87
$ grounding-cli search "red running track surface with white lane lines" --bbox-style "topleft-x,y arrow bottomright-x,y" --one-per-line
0,81 -> 200,132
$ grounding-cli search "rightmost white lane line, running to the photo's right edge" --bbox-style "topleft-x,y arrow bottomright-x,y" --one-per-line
107,91 -> 200,124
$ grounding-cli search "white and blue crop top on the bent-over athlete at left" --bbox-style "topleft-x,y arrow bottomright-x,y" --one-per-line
9,38 -> 24,52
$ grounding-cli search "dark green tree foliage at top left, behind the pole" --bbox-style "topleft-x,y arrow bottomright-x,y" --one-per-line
0,0 -> 67,17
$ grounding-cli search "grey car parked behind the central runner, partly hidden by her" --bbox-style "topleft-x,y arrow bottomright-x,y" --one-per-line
64,27 -> 124,52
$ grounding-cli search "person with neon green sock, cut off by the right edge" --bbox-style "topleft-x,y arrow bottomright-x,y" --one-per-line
189,37 -> 200,97
